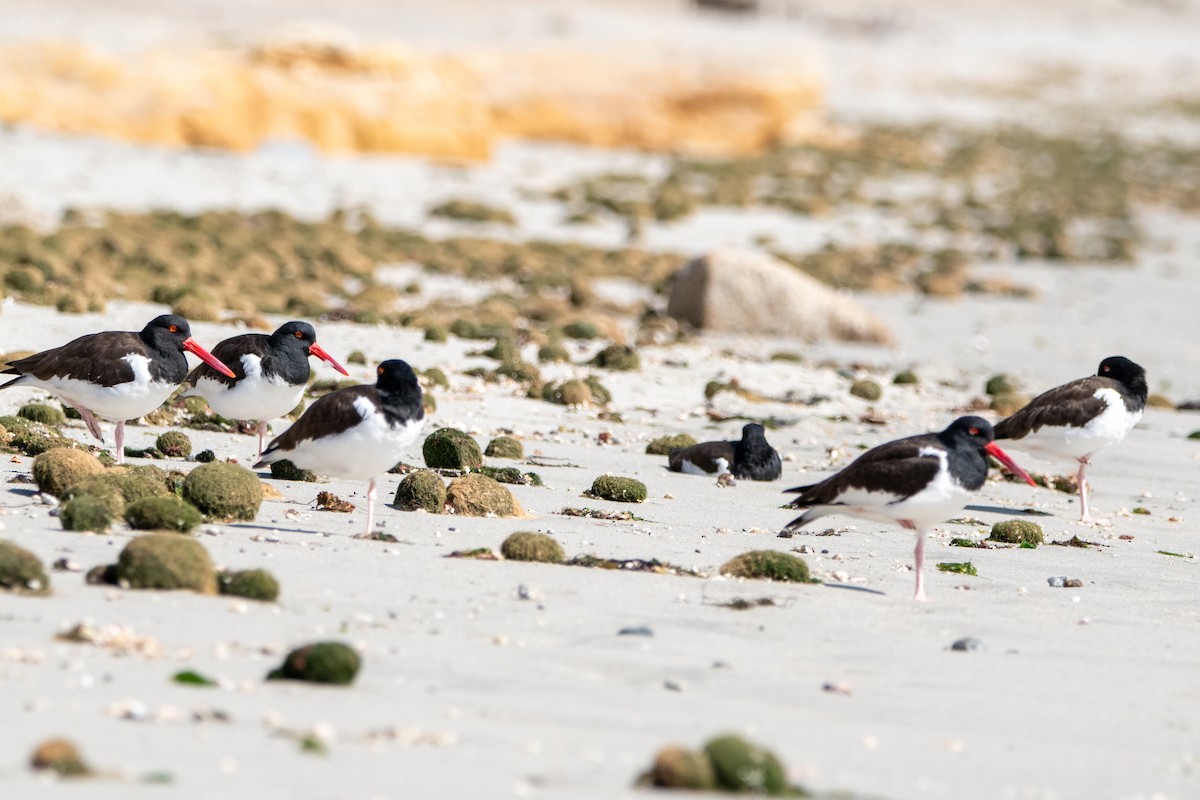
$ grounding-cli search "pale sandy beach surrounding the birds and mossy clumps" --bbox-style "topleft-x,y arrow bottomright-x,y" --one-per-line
0,0 -> 1200,800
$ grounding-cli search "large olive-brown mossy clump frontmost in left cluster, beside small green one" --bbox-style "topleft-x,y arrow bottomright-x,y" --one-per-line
116,534 -> 217,595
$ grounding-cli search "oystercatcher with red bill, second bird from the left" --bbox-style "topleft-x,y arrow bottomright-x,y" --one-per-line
184,321 -> 350,458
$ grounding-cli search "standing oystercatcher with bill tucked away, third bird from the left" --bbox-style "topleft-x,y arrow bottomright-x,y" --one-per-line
254,359 -> 425,534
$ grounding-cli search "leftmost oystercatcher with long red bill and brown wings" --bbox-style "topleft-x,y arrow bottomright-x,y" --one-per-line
0,314 -> 233,464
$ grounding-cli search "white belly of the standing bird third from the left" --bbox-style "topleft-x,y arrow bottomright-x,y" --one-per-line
278,414 -> 424,480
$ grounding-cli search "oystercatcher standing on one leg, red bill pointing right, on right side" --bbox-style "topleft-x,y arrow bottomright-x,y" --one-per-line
779,416 -> 1034,601
